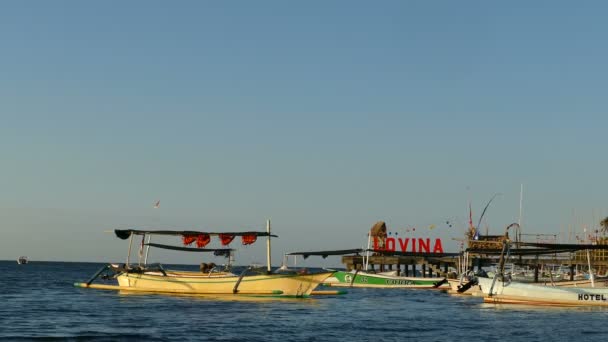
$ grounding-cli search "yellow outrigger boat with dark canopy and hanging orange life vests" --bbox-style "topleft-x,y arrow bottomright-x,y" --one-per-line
74,221 -> 333,297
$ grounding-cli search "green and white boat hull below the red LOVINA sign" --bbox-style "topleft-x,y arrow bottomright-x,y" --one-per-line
323,271 -> 449,289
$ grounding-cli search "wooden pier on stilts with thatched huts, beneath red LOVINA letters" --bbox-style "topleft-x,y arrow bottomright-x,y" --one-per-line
342,221 -> 608,281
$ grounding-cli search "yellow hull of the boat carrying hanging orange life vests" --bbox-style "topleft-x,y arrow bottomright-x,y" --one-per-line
117,272 -> 332,297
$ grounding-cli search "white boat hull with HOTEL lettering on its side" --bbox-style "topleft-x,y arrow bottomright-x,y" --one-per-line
478,278 -> 608,306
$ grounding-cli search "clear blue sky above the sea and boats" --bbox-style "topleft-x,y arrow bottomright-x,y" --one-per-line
0,1 -> 608,265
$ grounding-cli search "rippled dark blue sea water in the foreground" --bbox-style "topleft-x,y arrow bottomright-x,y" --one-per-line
0,261 -> 608,341
